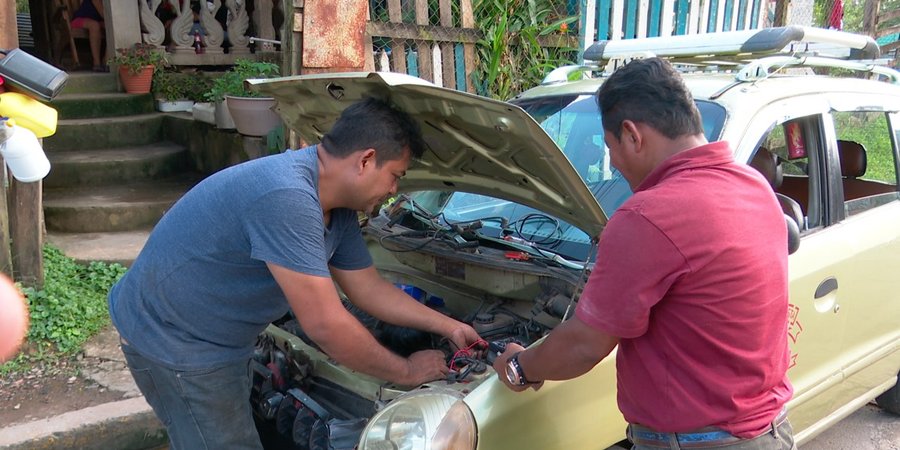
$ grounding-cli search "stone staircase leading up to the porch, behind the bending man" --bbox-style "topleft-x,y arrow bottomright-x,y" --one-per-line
43,73 -> 202,265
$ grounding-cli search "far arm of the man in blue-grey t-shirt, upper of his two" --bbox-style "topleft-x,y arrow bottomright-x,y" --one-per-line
331,266 -> 480,348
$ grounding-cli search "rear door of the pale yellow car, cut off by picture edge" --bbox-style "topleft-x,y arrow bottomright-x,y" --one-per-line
823,98 -> 900,425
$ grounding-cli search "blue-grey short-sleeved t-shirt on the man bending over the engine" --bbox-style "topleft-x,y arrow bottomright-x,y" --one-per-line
109,146 -> 372,370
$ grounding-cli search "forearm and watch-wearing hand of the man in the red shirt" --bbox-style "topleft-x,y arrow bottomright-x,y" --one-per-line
494,315 -> 619,391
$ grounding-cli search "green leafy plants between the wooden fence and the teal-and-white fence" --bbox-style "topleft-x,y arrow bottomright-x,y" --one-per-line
472,0 -> 578,100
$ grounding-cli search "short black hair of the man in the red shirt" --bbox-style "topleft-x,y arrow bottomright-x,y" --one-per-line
597,58 -> 703,139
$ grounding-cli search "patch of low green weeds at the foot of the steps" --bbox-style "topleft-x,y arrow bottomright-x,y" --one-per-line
0,245 -> 125,376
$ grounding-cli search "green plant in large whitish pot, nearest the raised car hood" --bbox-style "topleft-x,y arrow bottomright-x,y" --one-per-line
206,59 -> 281,136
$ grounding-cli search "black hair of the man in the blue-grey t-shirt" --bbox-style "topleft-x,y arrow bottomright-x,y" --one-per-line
322,97 -> 425,165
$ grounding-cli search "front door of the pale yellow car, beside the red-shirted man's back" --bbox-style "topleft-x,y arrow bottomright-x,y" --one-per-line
726,96 -> 853,438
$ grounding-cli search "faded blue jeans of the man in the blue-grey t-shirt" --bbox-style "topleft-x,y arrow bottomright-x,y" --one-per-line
122,341 -> 263,450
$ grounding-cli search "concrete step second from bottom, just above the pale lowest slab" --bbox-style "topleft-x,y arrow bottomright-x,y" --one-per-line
43,174 -> 200,233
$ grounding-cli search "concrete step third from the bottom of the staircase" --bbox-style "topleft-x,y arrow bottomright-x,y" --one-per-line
44,142 -> 190,188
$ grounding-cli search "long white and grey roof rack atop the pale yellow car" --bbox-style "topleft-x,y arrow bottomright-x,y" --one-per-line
584,25 -> 881,65
